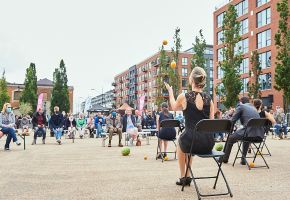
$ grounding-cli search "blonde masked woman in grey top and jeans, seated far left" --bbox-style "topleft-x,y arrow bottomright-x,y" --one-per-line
0,103 -> 21,150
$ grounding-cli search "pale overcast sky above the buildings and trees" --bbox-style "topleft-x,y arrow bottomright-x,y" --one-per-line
0,0 -> 224,110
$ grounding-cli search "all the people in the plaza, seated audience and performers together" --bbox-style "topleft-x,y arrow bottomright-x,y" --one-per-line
0,67 -> 289,188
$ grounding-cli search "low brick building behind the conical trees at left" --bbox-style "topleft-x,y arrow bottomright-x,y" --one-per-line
8,78 -> 74,114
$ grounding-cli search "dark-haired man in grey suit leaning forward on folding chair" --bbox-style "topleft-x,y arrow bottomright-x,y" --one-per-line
222,97 -> 264,165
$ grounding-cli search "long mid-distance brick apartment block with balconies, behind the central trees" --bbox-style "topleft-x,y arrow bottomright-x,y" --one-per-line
112,45 -> 213,109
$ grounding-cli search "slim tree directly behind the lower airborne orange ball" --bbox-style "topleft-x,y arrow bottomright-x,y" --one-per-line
169,27 -> 182,96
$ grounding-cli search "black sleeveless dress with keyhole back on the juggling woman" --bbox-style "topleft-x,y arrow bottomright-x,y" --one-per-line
178,91 -> 215,154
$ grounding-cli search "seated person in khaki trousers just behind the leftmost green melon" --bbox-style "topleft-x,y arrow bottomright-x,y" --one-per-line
107,111 -> 123,147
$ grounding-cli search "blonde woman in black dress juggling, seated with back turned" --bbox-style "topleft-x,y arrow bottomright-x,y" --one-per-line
165,67 -> 214,185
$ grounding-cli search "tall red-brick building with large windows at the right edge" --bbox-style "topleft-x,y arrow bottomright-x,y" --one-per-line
213,0 -> 290,108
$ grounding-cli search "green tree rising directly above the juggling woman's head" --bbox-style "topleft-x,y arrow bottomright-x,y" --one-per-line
191,29 -> 207,70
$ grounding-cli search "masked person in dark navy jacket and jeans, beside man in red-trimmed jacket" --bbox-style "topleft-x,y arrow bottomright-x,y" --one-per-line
50,106 -> 63,145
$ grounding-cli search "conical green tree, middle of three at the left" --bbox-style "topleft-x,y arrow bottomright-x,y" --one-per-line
20,63 -> 37,111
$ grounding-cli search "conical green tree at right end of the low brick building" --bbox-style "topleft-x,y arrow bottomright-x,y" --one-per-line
51,60 -> 70,112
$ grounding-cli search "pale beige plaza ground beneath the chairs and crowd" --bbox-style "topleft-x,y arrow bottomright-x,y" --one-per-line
0,136 -> 290,200
